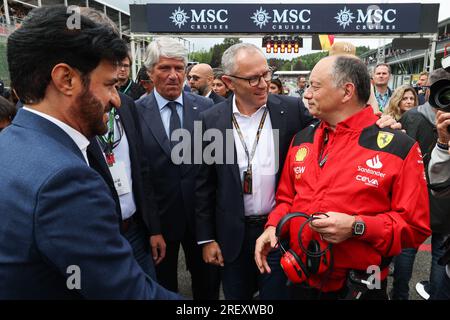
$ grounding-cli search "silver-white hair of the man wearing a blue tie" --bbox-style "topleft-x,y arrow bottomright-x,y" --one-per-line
144,37 -> 188,70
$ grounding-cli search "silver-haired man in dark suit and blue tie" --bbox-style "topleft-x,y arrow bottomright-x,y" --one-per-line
136,37 -> 219,299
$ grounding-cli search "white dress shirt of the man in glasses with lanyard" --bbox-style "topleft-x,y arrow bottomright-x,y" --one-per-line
233,96 -> 276,216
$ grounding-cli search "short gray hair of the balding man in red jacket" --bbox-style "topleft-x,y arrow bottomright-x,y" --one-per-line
331,55 -> 370,105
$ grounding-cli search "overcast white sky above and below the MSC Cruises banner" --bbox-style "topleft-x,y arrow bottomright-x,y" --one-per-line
107,0 -> 450,59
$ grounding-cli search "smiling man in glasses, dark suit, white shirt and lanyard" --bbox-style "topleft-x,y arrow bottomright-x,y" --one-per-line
196,44 -> 313,299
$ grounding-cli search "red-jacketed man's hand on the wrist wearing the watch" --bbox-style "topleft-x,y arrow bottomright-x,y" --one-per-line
310,212 -> 355,243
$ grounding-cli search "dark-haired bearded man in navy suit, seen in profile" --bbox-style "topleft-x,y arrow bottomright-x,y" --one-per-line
0,6 -> 179,299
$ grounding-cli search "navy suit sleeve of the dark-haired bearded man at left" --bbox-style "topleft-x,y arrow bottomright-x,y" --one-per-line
34,165 -> 179,299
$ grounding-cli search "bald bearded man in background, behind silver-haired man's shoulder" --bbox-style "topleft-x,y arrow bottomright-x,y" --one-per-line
188,63 -> 225,104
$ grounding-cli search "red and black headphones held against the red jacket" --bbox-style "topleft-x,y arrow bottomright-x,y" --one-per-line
275,212 -> 331,283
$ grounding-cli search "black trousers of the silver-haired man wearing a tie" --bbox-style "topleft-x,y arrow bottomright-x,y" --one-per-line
156,232 -> 220,300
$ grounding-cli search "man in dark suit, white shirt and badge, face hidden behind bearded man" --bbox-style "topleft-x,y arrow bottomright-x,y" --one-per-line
87,93 -> 166,279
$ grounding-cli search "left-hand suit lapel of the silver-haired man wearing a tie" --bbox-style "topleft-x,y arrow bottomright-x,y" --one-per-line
143,92 -> 171,158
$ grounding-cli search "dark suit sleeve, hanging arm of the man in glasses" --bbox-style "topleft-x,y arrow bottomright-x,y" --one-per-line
195,112 -> 217,241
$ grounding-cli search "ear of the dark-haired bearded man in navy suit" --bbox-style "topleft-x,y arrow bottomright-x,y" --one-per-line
51,63 -> 82,96
